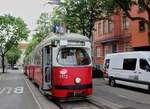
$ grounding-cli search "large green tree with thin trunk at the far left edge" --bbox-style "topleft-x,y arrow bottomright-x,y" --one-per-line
0,15 -> 29,73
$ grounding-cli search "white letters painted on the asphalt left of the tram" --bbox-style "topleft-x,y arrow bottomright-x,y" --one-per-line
0,87 -> 24,95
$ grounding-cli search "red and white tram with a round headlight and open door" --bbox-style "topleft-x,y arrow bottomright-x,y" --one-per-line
25,33 -> 92,99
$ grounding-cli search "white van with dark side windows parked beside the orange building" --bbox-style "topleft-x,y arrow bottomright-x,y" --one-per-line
104,51 -> 150,92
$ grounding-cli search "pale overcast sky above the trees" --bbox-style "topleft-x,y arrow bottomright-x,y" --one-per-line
0,0 -> 54,30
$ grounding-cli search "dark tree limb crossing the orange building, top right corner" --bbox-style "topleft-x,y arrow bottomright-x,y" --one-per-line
113,0 -> 150,44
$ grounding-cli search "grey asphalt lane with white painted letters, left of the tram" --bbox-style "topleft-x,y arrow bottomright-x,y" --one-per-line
0,70 -> 40,109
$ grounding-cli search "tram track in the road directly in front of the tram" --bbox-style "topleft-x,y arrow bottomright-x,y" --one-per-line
52,99 -> 110,109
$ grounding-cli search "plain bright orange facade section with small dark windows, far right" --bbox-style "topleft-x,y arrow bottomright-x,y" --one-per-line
131,5 -> 150,51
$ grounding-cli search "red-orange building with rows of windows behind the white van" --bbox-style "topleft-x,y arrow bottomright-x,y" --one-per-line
93,5 -> 149,70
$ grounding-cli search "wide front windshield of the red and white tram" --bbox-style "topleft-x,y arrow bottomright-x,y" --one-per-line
57,48 -> 91,66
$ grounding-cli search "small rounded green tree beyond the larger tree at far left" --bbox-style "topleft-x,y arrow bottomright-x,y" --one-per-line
6,46 -> 21,66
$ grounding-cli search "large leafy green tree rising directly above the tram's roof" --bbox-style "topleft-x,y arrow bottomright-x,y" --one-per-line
49,0 -> 113,38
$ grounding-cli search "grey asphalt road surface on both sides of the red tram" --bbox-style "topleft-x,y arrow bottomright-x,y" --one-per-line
0,70 -> 150,109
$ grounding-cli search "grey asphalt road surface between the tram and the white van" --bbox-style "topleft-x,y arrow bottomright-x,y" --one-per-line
92,79 -> 150,109
